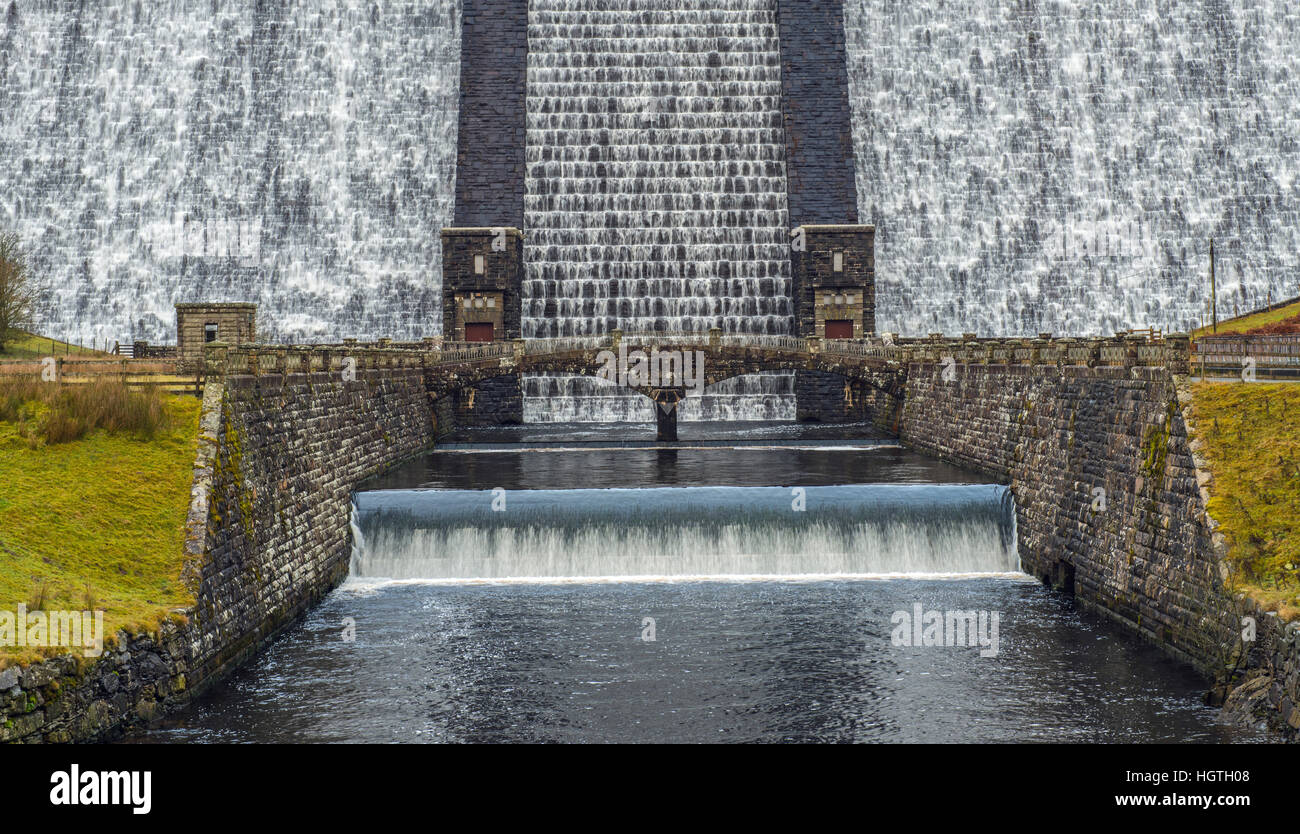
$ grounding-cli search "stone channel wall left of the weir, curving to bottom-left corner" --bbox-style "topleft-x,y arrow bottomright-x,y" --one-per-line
0,349 -> 436,742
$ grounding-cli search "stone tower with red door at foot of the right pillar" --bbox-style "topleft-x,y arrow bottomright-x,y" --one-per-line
790,225 -> 876,339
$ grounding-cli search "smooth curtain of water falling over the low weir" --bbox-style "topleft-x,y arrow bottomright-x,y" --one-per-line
352,485 -> 1019,579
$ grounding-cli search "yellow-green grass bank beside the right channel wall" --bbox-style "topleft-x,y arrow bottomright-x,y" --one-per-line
1192,382 -> 1300,620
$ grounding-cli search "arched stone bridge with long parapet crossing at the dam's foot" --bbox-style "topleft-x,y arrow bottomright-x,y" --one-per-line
204,330 -> 1190,439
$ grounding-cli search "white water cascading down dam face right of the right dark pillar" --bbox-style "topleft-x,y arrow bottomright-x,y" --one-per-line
844,0 -> 1300,335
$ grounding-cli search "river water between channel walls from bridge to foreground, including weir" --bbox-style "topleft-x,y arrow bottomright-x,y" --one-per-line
131,425 -> 1258,742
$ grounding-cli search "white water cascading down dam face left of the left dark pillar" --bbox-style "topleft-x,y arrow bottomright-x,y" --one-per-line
0,0 -> 460,343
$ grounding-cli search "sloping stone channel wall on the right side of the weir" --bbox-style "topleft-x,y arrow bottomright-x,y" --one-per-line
901,362 -> 1240,676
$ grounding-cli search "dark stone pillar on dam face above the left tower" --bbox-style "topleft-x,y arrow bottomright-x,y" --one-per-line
455,0 -> 528,229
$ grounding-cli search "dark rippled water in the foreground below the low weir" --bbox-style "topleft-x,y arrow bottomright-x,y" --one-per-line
140,579 -> 1251,742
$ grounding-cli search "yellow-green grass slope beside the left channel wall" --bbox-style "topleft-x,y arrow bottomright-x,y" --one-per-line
0,387 -> 200,668
